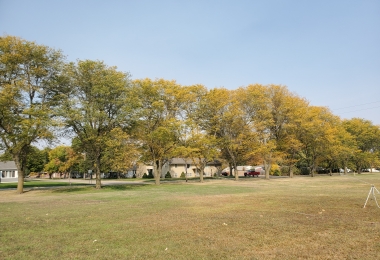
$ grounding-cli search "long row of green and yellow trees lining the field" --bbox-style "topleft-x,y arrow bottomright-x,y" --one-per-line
0,36 -> 380,193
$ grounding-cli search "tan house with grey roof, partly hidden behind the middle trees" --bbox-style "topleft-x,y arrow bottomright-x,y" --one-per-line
161,158 -> 222,178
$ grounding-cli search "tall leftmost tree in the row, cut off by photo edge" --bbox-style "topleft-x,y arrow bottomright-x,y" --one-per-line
0,36 -> 64,193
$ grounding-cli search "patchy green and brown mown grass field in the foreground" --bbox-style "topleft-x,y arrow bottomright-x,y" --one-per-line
0,174 -> 380,259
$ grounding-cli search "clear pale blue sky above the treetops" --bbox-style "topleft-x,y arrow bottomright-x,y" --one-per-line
0,0 -> 380,125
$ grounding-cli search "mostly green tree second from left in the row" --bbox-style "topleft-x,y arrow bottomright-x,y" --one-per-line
62,60 -> 133,189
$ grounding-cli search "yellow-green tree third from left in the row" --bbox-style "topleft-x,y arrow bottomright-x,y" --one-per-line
133,78 -> 189,185
